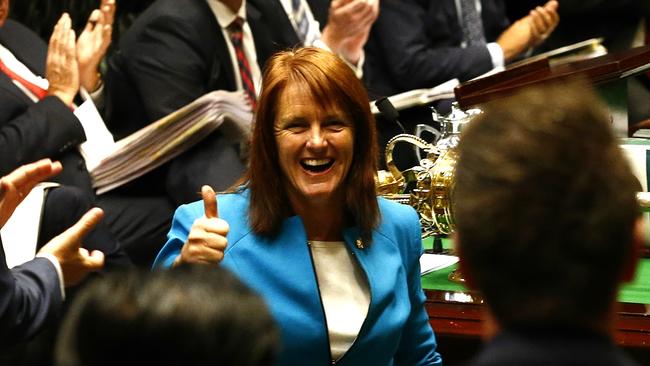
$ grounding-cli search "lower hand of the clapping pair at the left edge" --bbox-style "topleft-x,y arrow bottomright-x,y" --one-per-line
39,207 -> 104,287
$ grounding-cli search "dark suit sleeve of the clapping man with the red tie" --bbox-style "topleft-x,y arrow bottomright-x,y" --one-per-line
0,96 -> 86,176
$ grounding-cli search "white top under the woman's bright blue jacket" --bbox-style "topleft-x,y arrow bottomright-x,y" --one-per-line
309,241 -> 370,360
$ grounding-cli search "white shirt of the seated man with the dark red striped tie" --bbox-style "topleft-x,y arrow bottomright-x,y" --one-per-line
206,0 -> 262,94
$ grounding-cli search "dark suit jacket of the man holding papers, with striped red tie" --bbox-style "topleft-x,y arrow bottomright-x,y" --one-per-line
106,0 -> 288,203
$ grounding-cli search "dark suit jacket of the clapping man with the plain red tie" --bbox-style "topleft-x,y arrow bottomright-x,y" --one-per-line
0,19 -> 93,195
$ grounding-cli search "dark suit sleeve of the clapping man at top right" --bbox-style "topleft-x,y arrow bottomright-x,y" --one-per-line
367,0 -> 492,90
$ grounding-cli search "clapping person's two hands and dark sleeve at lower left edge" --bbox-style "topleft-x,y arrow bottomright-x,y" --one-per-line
0,159 -> 104,347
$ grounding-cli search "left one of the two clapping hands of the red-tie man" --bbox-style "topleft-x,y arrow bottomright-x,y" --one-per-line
45,13 -> 79,105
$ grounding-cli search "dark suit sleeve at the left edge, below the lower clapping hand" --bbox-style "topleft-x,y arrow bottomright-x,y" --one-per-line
0,243 -> 63,346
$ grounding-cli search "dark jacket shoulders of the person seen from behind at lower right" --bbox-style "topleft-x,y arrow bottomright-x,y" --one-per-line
467,329 -> 640,366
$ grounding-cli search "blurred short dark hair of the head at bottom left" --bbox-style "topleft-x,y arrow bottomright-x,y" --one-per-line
56,265 -> 279,366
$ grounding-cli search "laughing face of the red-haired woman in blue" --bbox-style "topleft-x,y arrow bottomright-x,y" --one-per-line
274,85 -> 354,209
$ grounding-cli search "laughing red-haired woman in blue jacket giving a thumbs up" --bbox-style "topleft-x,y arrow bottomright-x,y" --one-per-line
154,48 -> 441,365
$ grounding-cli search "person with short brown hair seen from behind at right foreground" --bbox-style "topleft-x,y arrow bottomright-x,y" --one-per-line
454,81 -> 643,366
